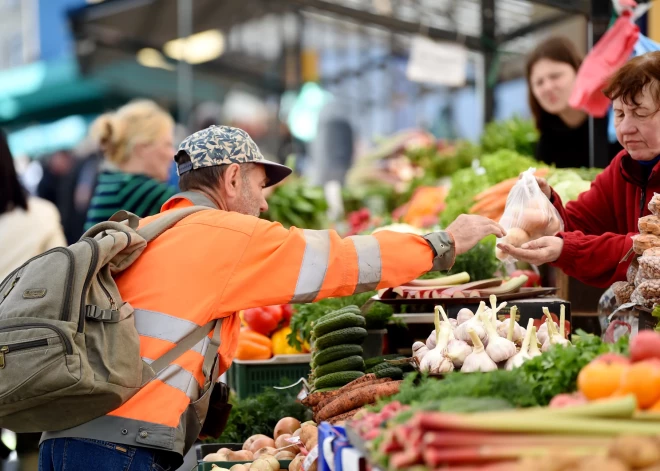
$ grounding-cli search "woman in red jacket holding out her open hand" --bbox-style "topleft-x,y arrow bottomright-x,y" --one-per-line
498,52 -> 660,288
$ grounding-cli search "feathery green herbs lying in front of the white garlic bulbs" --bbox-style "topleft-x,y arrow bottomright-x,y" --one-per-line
378,331 -> 628,407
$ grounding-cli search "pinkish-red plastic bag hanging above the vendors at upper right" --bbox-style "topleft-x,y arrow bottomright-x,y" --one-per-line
568,11 -> 639,118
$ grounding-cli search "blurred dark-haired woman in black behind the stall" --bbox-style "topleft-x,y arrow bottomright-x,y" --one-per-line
526,37 -> 621,168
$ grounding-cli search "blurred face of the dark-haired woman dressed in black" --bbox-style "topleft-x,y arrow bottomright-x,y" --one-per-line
529,59 -> 577,114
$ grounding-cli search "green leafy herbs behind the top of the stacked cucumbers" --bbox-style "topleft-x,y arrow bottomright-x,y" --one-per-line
287,291 -> 394,348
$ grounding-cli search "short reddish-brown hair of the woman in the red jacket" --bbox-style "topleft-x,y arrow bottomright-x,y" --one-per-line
604,51 -> 660,107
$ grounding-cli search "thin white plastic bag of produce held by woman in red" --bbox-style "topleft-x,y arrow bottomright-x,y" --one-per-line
497,168 -> 564,262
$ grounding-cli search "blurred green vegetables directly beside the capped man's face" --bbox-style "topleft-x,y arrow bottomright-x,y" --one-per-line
263,178 -> 328,229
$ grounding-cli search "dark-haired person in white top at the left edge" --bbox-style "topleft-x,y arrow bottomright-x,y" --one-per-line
0,131 -> 66,280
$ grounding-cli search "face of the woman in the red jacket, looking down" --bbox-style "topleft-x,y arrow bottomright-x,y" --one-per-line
613,86 -> 660,160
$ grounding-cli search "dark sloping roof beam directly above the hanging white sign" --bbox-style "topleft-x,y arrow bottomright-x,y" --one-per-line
274,0 -> 484,51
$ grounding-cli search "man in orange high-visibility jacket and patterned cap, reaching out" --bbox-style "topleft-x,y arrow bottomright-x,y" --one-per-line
40,126 -> 504,471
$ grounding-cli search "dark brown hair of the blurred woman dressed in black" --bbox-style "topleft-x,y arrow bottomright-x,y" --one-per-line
526,36 -> 583,129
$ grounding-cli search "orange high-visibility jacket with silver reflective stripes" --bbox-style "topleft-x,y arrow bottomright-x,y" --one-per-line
44,193 -> 453,455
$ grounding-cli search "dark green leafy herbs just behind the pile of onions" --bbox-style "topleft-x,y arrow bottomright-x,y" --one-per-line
213,388 -> 311,443
